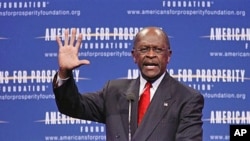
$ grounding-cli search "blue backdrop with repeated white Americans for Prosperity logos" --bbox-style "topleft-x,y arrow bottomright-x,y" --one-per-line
0,0 -> 250,141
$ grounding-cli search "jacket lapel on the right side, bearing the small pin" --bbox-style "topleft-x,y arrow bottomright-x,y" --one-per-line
133,74 -> 174,140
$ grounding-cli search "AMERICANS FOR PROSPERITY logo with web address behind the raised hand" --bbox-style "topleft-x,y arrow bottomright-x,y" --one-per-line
36,27 -> 142,57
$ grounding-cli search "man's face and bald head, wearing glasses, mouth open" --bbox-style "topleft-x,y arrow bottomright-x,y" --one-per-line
132,29 -> 171,80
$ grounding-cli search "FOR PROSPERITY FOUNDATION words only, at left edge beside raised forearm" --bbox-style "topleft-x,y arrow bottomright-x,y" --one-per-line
0,70 -> 56,93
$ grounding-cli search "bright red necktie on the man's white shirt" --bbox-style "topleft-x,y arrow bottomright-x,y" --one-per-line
137,82 -> 151,125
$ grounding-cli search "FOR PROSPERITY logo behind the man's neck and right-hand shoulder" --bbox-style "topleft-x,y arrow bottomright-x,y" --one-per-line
124,68 -> 250,91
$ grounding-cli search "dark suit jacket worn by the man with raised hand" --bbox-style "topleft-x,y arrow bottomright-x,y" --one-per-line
54,73 -> 204,141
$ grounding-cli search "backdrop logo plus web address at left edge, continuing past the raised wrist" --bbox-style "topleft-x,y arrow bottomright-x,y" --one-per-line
0,69 -> 86,97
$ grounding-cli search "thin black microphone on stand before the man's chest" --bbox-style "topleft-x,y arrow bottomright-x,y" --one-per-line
126,93 -> 135,141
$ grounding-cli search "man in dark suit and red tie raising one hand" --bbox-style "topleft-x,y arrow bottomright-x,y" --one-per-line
54,27 -> 204,141
